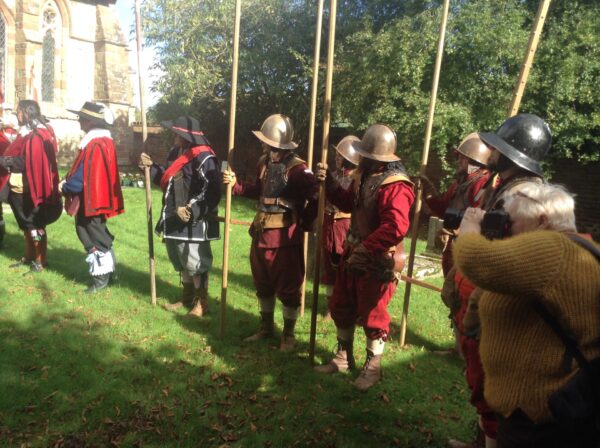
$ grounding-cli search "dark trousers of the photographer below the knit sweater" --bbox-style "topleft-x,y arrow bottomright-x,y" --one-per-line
496,410 -> 600,448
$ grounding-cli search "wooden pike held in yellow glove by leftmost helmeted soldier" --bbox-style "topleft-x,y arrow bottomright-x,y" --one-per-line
219,0 -> 242,339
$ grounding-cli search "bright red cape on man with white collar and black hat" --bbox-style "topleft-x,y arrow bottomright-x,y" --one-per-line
67,137 -> 125,218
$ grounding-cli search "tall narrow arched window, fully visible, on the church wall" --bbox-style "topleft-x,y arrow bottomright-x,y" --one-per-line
41,1 -> 61,102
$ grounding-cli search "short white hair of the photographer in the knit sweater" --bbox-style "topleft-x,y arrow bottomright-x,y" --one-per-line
504,182 -> 577,232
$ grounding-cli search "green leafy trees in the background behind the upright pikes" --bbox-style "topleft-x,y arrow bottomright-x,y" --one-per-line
145,0 -> 600,177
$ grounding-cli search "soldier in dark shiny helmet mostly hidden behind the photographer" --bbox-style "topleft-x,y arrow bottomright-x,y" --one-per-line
450,114 -> 552,447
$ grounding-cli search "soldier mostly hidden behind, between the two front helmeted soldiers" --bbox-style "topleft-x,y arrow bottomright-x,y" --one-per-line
321,135 -> 360,319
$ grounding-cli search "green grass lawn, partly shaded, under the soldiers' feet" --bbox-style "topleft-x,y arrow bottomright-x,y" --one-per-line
0,188 -> 475,447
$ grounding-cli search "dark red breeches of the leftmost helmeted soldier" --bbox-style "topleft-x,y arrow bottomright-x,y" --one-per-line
250,238 -> 306,307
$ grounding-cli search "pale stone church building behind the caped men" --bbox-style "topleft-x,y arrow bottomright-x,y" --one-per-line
0,0 -> 134,165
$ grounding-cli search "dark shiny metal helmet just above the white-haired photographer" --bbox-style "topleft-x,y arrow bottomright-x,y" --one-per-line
479,114 -> 552,176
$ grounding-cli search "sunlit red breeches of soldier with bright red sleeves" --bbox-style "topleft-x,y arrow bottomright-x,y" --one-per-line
329,253 -> 396,340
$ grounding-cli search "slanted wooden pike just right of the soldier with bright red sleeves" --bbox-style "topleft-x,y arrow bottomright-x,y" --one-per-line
400,0 -> 450,346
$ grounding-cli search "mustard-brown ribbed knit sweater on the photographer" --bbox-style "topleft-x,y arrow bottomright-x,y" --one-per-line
454,231 -> 600,422
